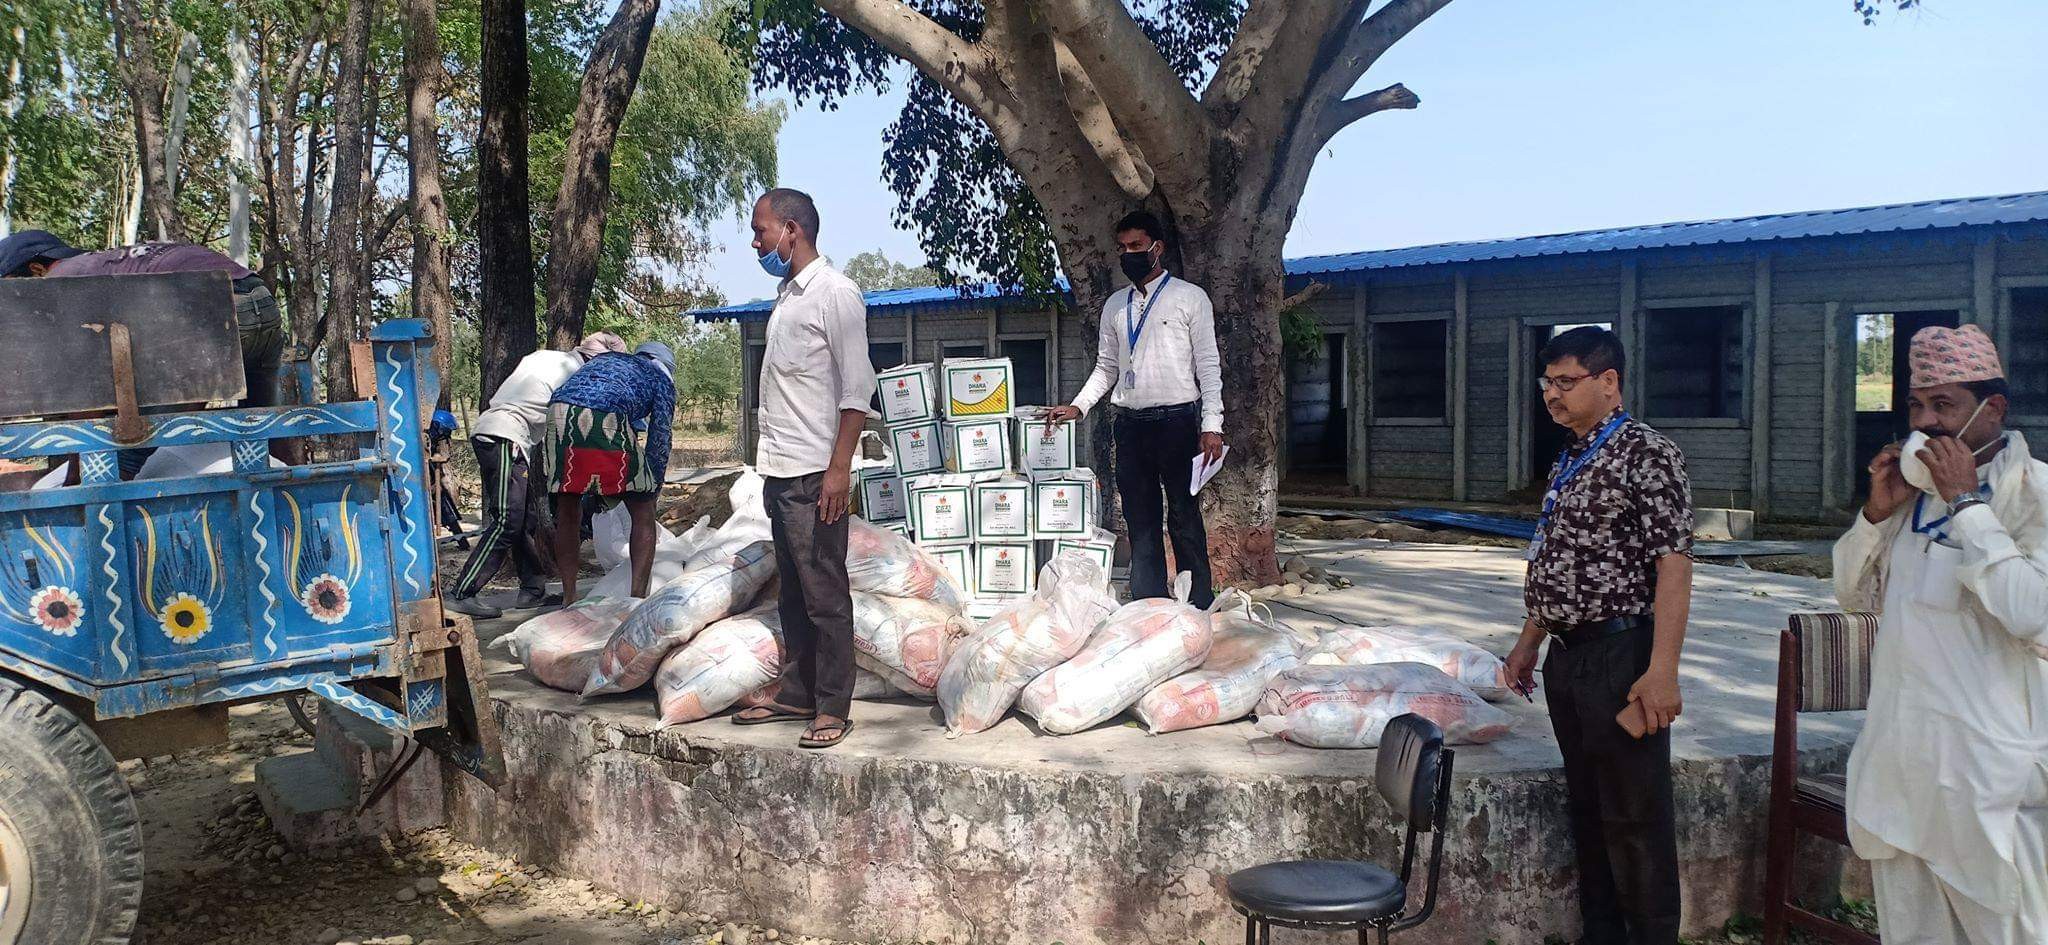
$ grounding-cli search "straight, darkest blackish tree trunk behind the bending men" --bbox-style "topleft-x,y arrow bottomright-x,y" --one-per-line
477,0 -> 541,402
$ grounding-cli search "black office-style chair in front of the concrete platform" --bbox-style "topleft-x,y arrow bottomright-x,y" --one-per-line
1229,713 -> 1456,945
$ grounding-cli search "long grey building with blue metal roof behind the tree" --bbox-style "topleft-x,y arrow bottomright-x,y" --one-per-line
694,193 -> 2048,521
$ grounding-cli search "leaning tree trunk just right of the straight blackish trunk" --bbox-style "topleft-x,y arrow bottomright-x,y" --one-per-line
547,0 -> 662,351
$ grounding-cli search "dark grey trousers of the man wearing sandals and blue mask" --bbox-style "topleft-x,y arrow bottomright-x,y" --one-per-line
762,474 -> 854,720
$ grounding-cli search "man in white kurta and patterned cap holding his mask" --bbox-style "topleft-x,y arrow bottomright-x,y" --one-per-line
1835,326 -> 2048,945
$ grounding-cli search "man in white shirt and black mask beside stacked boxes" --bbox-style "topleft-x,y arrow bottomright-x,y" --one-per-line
1049,211 -> 1223,607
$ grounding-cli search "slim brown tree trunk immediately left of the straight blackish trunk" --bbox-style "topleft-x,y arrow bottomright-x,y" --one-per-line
406,0 -> 455,408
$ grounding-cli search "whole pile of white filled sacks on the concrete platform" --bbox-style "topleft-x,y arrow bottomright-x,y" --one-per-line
500,469 -> 1513,748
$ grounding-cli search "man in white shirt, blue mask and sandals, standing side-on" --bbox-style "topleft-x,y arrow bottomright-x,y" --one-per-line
733,187 -> 874,748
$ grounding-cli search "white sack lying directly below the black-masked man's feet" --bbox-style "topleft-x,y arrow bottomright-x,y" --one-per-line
1018,572 -> 1210,736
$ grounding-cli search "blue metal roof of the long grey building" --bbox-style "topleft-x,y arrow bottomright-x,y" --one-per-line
690,191 -> 2048,322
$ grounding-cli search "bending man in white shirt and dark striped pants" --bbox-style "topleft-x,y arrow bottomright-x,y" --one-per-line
442,332 -> 627,619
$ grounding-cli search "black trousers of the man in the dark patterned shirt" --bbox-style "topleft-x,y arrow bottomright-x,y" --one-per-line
1544,627 -> 1679,945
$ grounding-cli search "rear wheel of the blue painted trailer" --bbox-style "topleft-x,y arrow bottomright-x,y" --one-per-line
0,676 -> 141,945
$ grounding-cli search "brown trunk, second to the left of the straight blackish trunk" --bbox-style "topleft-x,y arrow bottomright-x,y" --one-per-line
328,0 -> 375,402
